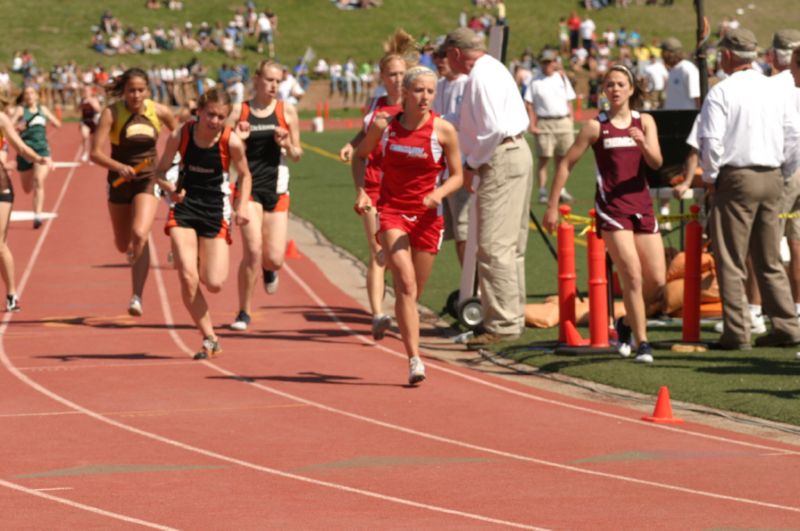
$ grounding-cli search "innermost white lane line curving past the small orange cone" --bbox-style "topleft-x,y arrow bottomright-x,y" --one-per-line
283,264 -> 800,456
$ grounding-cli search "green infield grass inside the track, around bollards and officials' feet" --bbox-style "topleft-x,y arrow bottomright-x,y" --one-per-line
292,132 -> 800,425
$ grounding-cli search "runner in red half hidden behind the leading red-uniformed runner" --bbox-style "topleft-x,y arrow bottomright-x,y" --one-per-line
339,30 -> 417,340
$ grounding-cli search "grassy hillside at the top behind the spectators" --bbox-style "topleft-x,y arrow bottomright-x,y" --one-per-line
0,0 -> 796,74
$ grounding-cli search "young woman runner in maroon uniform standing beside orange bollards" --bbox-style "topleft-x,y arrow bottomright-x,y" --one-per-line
544,65 -> 666,363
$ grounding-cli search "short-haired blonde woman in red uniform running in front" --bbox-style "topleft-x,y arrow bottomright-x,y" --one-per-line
356,66 -> 462,384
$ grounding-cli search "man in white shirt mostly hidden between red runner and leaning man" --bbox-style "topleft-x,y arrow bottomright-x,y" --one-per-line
432,46 -> 472,264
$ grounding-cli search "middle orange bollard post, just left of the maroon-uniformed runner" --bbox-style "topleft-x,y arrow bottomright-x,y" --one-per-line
586,209 -> 609,348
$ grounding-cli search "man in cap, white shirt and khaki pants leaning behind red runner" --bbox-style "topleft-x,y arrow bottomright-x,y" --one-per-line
444,28 -> 533,348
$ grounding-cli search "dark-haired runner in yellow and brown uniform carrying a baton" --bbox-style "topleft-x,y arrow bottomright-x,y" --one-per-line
91,68 -> 176,317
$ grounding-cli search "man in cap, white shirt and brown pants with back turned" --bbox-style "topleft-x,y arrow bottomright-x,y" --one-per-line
698,28 -> 800,350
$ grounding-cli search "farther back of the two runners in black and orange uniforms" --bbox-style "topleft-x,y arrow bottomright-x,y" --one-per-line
228,61 -> 303,330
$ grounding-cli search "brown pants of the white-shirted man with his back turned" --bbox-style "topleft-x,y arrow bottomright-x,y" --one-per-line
711,166 -> 800,347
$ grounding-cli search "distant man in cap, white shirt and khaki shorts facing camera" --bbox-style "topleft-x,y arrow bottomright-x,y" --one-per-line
525,50 -> 575,203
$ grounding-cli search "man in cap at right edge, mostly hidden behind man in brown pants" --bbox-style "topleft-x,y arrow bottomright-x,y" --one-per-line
770,29 -> 800,324
